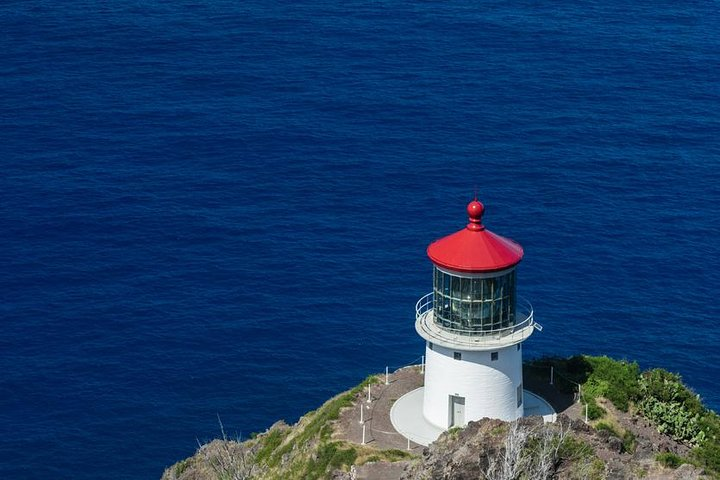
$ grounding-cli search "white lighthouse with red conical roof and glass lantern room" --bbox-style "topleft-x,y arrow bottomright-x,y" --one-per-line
415,200 -> 539,430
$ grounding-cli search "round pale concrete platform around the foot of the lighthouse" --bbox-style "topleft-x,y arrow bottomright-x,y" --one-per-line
390,387 -> 556,446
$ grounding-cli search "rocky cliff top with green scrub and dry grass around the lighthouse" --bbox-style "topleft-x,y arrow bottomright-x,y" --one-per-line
162,357 -> 720,480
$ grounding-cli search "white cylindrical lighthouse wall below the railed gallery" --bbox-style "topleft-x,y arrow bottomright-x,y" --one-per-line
423,342 -> 523,429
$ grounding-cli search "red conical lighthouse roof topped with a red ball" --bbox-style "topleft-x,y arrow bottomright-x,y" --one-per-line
427,199 -> 523,273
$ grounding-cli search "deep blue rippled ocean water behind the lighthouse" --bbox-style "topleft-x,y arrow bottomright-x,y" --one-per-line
0,0 -> 720,480
